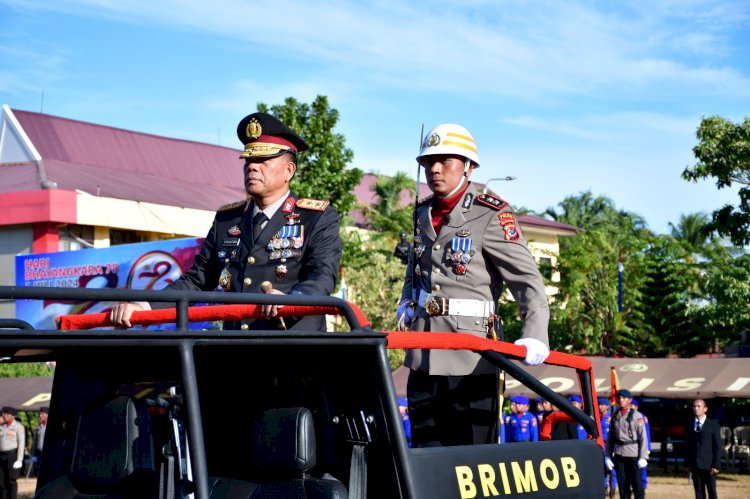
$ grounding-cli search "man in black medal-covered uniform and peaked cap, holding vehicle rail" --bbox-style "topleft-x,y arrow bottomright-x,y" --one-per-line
110,113 -> 341,331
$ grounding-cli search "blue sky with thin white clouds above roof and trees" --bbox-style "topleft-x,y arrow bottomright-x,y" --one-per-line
0,0 -> 750,232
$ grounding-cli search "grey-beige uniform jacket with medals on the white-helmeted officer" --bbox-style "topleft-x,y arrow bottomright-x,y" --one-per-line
401,183 -> 549,376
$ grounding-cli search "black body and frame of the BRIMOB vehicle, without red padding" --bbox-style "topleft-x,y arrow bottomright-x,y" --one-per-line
0,287 -> 603,499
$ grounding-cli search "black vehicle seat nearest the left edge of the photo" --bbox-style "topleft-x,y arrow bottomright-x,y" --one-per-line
35,396 -> 159,499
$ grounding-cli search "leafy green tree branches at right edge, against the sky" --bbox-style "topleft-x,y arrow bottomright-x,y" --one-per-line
682,116 -> 750,246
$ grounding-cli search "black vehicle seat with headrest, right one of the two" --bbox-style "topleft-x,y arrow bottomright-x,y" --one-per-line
211,407 -> 348,499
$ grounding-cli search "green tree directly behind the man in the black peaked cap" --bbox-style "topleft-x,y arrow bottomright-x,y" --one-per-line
258,95 -> 362,217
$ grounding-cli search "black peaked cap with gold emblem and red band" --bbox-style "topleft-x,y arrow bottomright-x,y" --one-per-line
237,113 -> 310,158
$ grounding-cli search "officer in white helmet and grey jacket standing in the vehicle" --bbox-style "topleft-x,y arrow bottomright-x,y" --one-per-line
396,124 -> 549,447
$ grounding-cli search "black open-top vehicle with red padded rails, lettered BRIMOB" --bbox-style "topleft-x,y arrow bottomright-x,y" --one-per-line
0,287 -> 603,499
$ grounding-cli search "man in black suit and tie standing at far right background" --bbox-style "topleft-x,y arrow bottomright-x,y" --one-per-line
684,399 -> 721,499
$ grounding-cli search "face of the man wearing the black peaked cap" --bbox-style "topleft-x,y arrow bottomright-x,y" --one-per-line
244,154 -> 297,207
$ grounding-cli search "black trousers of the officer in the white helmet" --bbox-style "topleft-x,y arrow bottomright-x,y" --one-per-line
406,370 -> 499,447
